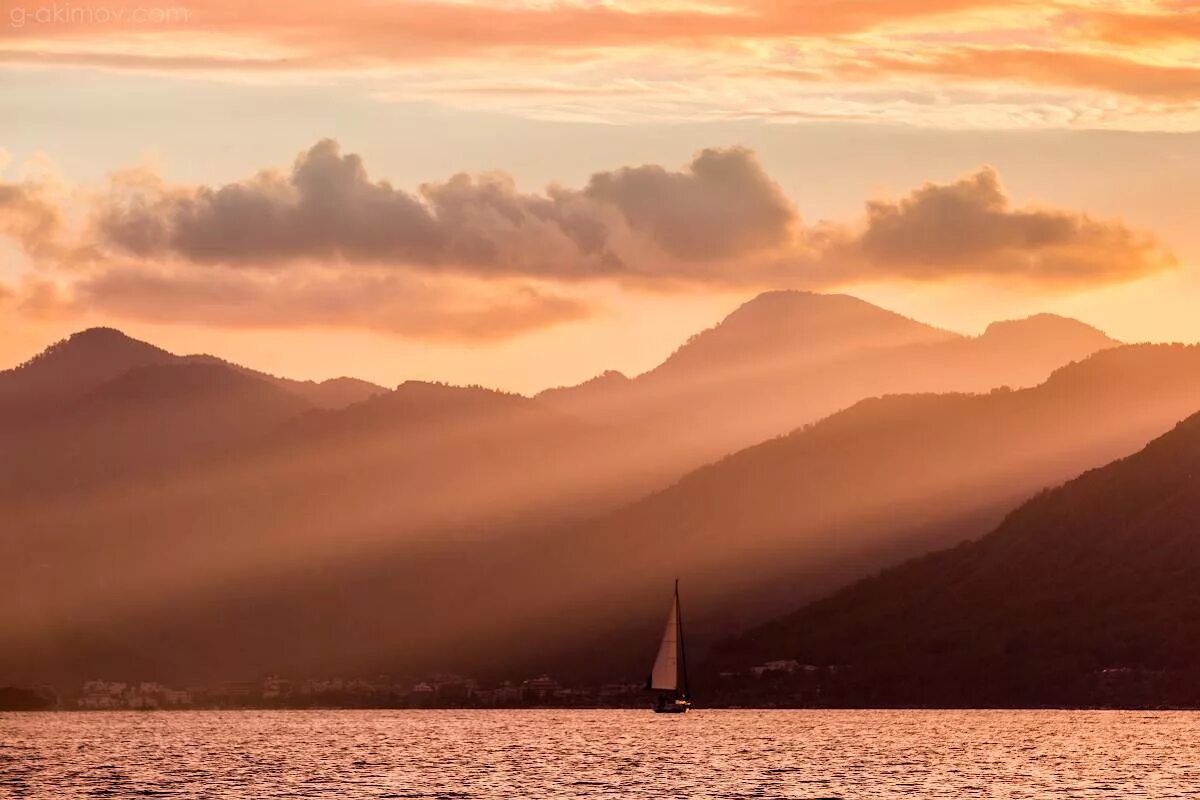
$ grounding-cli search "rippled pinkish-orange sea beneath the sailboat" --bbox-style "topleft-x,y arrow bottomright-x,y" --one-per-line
0,709 -> 1200,800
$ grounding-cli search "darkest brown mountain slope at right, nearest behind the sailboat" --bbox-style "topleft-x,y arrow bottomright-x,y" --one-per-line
705,407 -> 1200,708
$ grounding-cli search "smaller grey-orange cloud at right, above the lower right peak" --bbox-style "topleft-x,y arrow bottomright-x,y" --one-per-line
824,168 -> 1175,284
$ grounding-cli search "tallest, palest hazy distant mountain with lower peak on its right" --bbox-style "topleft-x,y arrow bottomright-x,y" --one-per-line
538,291 -> 1117,465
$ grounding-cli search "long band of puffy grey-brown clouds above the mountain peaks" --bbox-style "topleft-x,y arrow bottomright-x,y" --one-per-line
96,140 -> 1174,287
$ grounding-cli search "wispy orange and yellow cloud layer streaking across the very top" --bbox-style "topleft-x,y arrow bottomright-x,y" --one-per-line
0,0 -> 1200,130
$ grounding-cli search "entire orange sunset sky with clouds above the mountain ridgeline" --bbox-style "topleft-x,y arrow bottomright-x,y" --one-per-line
0,0 -> 1200,391
